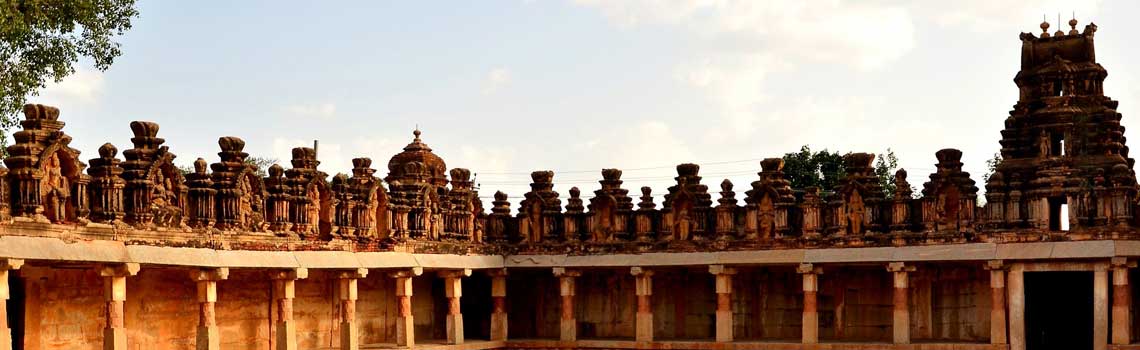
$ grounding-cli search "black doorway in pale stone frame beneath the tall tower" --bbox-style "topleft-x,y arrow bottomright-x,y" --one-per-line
1025,271 -> 1092,350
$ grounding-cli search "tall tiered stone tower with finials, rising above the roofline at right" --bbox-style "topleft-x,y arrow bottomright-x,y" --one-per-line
986,19 -> 1137,237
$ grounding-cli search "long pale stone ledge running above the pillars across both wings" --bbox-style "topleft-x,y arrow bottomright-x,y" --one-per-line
0,236 -> 1140,269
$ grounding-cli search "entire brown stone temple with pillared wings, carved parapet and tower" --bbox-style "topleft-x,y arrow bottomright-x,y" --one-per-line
0,21 -> 1140,350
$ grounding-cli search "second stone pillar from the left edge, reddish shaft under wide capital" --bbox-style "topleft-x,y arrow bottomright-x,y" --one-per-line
98,263 -> 139,350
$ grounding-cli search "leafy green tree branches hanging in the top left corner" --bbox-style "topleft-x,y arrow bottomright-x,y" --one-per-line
0,0 -> 138,145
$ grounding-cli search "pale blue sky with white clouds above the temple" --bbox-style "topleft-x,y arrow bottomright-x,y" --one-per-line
30,0 -> 1140,206
